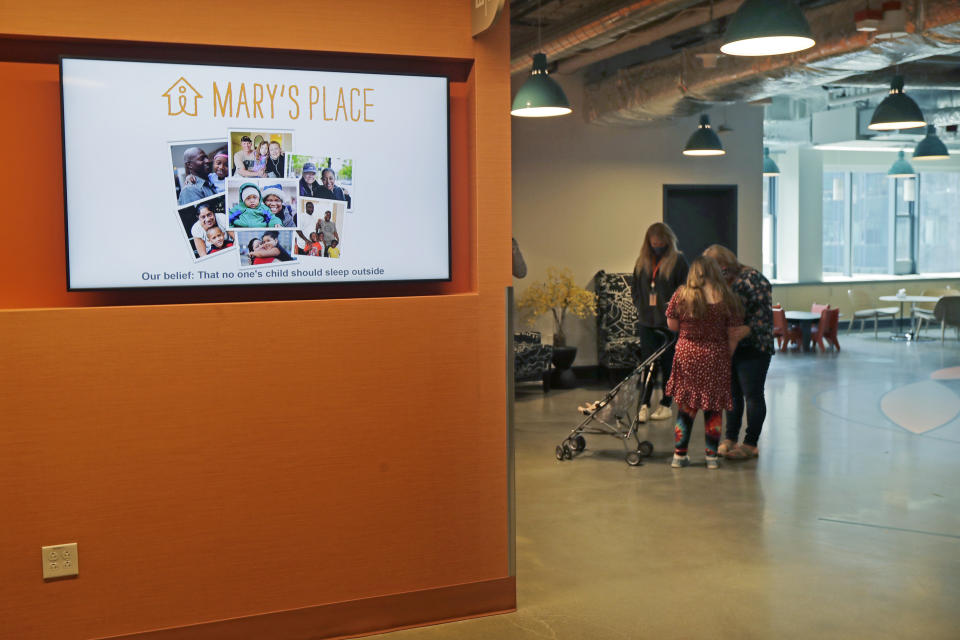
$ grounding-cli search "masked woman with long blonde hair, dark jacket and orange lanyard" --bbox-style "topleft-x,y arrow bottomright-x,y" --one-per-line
630,222 -> 688,422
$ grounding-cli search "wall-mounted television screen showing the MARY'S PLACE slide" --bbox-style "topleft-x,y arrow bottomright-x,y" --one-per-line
60,58 -> 450,289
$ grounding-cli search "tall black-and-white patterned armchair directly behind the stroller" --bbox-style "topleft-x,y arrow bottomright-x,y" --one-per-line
594,271 -> 640,375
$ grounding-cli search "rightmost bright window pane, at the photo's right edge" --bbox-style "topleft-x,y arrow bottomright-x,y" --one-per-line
917,173 -> 960,273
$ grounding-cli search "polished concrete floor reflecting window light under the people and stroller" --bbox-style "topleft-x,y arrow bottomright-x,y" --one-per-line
384,332 -> 960,640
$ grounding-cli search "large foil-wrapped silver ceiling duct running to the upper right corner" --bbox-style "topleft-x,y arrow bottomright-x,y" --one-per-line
584,0 -> 960,125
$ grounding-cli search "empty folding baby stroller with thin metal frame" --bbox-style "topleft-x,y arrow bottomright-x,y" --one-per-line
557,334 -> 676,467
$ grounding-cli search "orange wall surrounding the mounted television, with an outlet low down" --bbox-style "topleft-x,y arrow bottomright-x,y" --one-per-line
0,0 -> 513,640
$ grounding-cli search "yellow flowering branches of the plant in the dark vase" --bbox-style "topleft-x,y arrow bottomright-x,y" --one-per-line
517,267 -> 597,347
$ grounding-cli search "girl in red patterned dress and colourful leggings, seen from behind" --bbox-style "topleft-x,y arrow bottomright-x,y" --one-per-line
666,257 -> 750,469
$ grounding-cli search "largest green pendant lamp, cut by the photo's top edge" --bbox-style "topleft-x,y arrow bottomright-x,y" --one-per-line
720,0 -> 816,56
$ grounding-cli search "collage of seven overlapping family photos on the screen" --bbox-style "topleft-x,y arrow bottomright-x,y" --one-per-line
169,131 -> 354,267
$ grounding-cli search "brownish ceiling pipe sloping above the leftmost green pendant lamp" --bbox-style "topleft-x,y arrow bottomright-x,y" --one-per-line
510,0 -> 704,74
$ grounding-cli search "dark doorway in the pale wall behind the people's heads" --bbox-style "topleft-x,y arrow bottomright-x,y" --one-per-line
663,184 -> 737,262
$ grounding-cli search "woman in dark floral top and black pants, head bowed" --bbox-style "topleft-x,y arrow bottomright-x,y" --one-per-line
703,244 -> 774,459
